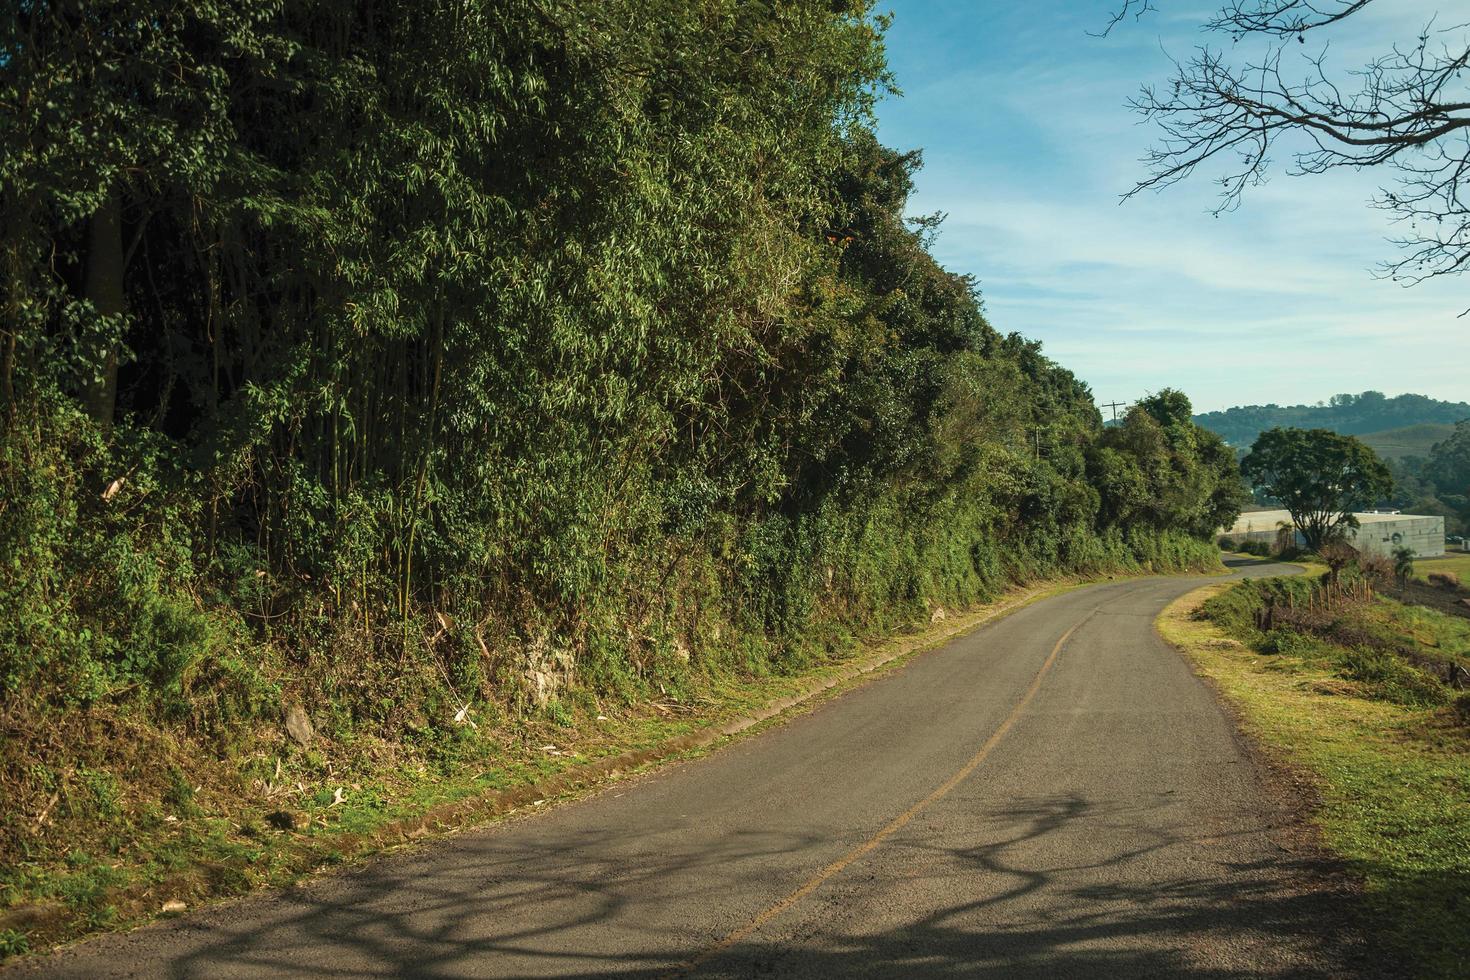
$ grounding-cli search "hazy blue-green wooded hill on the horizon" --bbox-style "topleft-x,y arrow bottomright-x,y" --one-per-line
1194,391 -> 1470,455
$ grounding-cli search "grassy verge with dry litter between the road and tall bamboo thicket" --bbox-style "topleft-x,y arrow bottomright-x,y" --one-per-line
0,576 -> 1111,958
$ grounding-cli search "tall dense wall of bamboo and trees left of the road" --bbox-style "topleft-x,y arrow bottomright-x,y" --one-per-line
0,0 -> 1242,952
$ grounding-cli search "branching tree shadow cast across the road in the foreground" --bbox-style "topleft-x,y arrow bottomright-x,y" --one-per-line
91,796 -> 1392,979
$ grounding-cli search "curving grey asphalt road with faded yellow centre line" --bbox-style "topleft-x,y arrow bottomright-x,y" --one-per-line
25,563 -> 1358,977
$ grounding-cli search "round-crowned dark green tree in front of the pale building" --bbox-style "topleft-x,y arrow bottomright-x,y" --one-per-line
1241,429 -> 1394,551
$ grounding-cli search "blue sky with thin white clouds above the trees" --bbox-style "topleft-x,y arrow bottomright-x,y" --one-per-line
879,0 -> 1470,411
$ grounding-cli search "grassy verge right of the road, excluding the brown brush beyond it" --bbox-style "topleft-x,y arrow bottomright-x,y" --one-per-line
1158,585 -> 1470,977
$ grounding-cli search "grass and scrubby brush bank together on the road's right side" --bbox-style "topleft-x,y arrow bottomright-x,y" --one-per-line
1160,560 -> 1470,977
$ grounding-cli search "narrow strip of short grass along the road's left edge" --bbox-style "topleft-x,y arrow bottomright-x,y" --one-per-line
0,574 -> 1111,970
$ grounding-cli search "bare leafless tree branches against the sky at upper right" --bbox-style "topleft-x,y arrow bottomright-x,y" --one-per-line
1107,0 -> 1470,282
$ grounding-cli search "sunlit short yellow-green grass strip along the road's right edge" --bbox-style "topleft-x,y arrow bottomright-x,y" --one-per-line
1155,583 -> 1470,977
